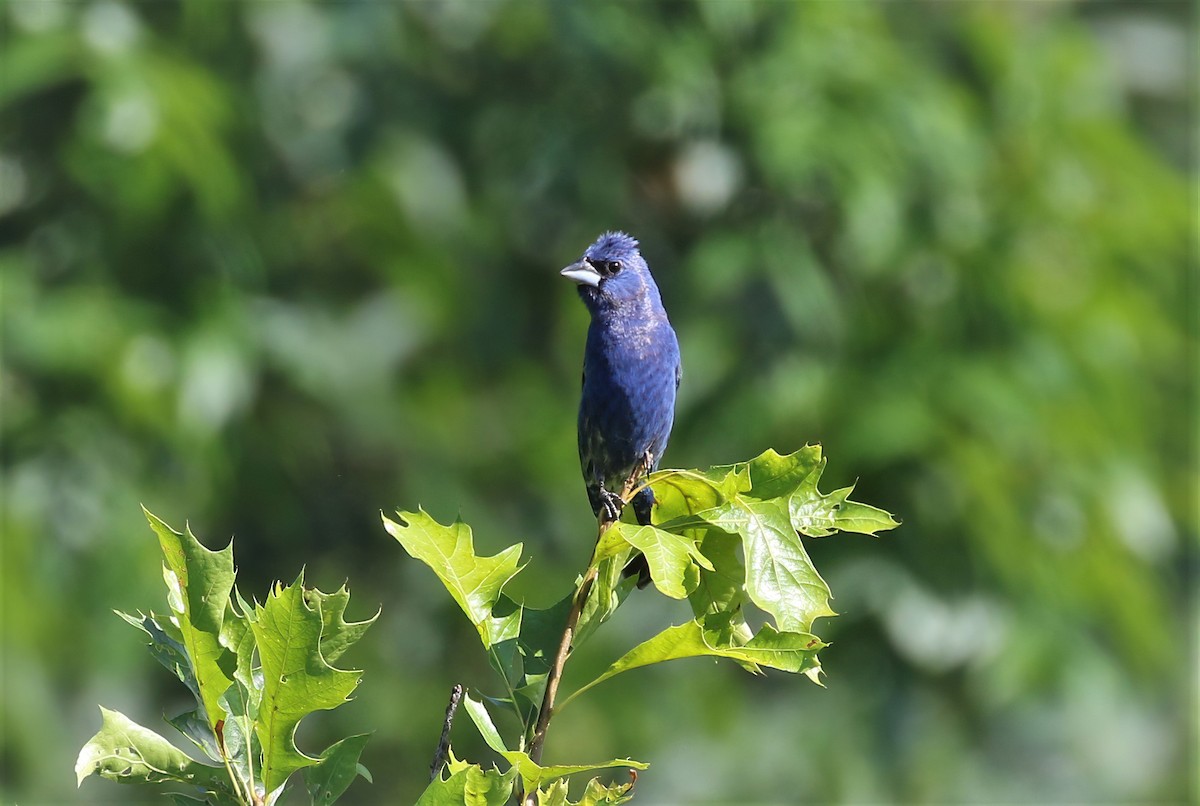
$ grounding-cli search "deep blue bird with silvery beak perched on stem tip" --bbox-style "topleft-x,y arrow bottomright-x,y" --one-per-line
560,231 -> 683,588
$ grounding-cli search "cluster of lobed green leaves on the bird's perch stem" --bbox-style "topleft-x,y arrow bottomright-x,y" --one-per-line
383,445 -> 898,804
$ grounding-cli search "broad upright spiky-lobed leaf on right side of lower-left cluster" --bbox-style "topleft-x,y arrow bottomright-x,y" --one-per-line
251,572 -> 362,792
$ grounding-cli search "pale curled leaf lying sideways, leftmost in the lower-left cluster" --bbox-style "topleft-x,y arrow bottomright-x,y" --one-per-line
76,708 -> 232,796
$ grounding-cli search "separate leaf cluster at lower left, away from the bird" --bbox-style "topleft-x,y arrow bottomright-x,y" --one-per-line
76,511 -> 378,806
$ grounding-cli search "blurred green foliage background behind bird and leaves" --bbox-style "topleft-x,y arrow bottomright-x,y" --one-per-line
0,0 -> 1200,804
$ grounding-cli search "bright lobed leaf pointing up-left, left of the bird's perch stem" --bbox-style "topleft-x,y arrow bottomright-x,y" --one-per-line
383,510 -> 522,649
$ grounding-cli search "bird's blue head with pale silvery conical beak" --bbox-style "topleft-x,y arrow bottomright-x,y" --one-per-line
562,231 -> 661,313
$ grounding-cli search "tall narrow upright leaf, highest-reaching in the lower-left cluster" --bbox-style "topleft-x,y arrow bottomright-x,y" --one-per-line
142,507 -> 235,729
